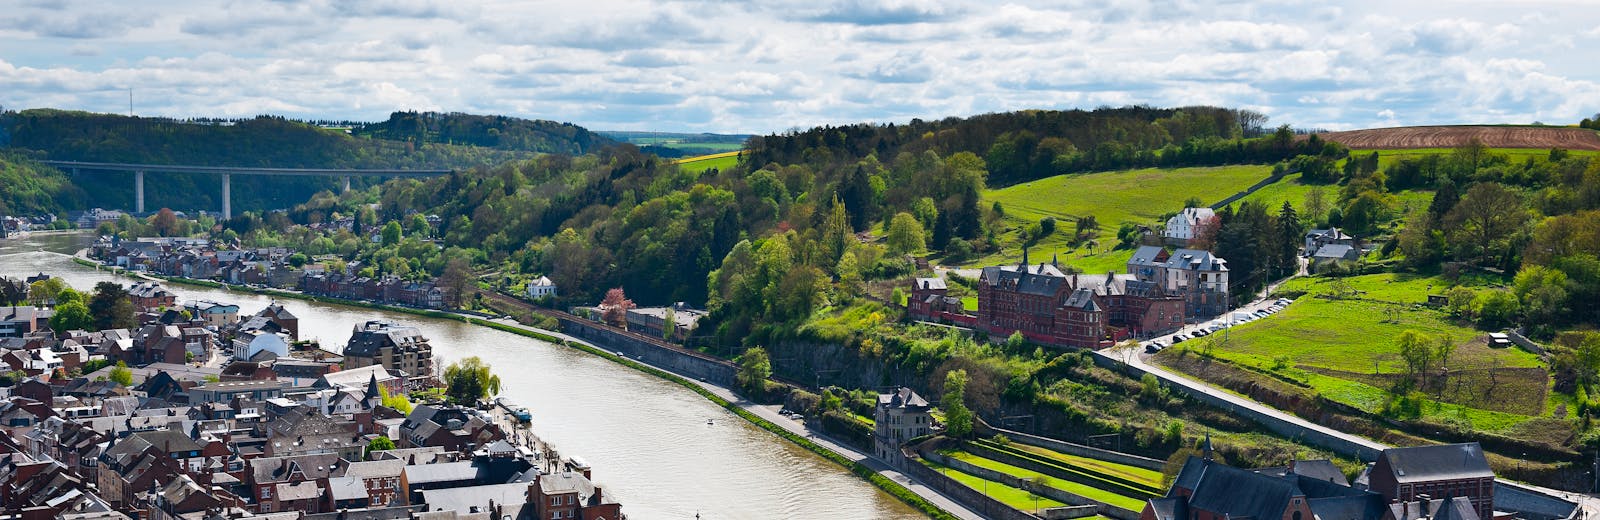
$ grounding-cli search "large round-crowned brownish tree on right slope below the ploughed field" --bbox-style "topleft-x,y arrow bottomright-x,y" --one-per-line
1445,182 -> 1528,264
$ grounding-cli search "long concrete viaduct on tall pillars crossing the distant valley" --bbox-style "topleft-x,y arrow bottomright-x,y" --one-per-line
42,160 -> 451,219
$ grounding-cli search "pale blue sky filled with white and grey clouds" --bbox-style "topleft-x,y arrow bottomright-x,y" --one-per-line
0,0 -> 1600,133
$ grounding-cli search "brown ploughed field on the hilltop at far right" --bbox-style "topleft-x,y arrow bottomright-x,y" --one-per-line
1320,126 -> 1600,150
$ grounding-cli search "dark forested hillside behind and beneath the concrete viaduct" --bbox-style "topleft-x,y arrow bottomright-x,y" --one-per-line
0,109 -> 587,211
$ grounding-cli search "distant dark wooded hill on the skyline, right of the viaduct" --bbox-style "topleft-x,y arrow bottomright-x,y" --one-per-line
352,112 -> 618,155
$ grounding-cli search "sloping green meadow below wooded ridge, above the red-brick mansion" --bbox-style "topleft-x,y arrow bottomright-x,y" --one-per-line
971,165 -> 1272,265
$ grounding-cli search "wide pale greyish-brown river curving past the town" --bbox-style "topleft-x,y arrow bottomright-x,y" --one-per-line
0,234 -> 920,520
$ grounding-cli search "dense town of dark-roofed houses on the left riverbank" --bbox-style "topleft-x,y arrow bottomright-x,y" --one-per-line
0,274 -> 626,520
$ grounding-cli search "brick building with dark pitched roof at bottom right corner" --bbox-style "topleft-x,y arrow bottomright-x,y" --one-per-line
1366,442 -> 1494,518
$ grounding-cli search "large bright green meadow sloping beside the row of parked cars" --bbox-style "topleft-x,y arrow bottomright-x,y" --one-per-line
1157,274 -> 1550,432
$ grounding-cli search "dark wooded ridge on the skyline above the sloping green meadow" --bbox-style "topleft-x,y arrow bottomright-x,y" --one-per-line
747,106 -> 1322,184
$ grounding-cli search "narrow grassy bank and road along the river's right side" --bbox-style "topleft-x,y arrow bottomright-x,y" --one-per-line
72,251 -> 981,520
